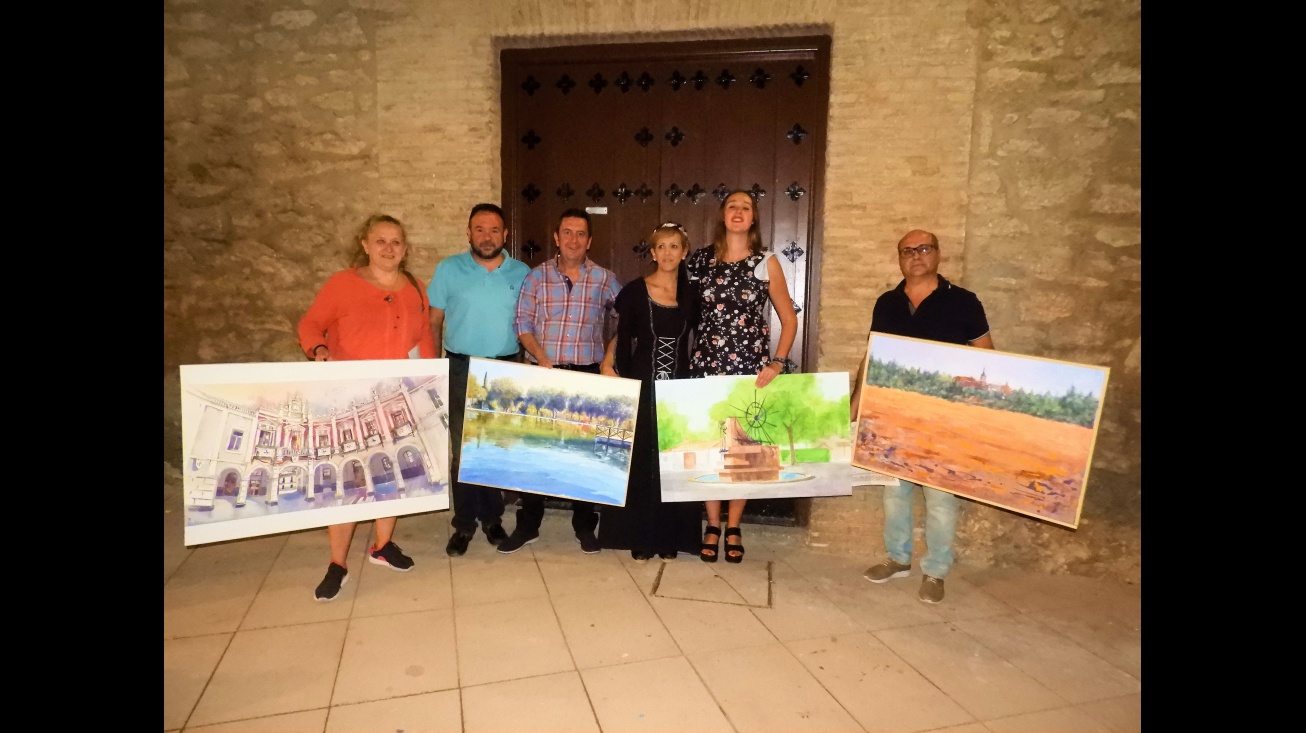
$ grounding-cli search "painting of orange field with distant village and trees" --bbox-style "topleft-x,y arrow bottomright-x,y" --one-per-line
853,332 -> 1110,528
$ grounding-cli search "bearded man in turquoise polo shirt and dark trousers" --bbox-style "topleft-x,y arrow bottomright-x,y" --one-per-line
426,204 -> 530,557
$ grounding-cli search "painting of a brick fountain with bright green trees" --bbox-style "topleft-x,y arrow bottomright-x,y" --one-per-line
653,371 -> 868,502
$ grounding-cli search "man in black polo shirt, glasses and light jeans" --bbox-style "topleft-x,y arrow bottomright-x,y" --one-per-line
852,229 -> 994,604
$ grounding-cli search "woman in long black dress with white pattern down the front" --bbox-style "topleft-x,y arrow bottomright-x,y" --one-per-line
598,223 -> 701,562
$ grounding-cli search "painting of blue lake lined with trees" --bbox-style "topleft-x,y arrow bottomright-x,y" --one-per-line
458,357 -> 641,507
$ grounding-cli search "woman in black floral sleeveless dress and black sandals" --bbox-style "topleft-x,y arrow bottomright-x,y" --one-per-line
686,189 -> 798,563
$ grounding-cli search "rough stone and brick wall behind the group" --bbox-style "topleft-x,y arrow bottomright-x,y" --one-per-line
163,0 -> 1141,578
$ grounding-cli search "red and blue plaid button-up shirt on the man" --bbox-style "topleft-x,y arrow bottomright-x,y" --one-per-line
516,257 -> 622,365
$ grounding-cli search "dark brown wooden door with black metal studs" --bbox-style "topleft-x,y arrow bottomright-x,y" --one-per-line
500,37 -> 831,520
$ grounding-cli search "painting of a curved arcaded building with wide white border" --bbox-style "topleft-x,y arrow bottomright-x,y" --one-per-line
180,359 -> 449,545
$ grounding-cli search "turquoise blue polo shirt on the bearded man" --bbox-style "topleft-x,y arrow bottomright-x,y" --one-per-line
426,250 -> 530,358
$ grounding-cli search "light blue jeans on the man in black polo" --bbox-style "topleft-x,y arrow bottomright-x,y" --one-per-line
884,478 -> 961,579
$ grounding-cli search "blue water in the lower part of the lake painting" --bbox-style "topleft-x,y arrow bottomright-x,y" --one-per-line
458,440 -> 629,506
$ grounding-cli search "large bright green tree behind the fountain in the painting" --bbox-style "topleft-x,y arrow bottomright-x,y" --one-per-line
705,374 -> 849,465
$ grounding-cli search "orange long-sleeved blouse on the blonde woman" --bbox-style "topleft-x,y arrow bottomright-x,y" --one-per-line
299,268 -> 436,362
